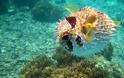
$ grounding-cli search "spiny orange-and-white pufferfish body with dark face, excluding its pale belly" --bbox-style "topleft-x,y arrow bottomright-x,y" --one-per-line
57,7 -> 116,51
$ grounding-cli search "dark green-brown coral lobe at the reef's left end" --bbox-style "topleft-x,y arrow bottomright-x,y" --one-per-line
20,55 -> 53,78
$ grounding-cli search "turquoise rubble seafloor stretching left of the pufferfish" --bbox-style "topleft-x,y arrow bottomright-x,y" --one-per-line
0,12 -> 56,78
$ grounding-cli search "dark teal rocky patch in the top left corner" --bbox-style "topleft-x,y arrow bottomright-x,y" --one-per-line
0,0 -> 39,14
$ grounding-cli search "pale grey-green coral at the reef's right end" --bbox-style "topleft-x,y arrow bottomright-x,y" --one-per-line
89,55 -> 124,78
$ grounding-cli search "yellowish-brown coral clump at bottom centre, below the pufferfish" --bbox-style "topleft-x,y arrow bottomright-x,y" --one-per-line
51,60 -> 108,78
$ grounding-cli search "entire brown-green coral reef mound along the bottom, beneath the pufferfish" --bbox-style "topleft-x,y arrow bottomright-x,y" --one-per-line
20,48 -> 124,78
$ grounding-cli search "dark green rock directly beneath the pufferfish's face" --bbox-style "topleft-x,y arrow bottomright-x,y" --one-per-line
53,47 -> 84,66
